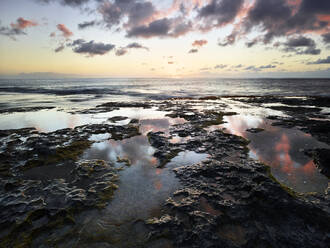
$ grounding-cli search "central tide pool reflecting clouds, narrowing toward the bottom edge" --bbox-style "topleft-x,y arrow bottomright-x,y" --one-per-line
82,135 -> 208,247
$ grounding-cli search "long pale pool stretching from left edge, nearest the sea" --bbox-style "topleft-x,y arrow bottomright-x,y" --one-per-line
0,108 -> 186,134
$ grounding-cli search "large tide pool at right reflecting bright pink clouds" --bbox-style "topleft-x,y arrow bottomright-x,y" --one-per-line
209,115 -> 328,193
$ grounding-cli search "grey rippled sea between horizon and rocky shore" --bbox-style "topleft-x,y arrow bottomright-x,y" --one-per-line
0,78 -> 330,108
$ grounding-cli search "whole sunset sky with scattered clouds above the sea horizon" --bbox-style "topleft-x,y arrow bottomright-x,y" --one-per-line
0,0 -> 330,78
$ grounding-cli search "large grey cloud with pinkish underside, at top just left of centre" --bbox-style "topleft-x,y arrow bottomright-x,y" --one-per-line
99,0 -> 193,38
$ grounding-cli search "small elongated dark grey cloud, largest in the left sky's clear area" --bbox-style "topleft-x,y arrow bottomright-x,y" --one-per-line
70,39 -> 115,57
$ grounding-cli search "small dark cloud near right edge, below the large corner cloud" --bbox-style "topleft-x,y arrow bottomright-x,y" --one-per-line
283,36 -> 321,55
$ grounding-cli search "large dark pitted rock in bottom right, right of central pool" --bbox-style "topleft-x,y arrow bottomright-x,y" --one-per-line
148,160 -> 330,248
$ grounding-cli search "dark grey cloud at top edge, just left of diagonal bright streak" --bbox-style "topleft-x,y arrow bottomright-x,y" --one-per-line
198,0 -> 244,29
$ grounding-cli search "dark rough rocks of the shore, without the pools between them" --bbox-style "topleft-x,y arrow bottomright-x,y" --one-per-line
0,96 -> 330,247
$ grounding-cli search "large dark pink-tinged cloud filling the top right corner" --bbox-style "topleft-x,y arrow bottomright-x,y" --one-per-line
220,0 -> 330,46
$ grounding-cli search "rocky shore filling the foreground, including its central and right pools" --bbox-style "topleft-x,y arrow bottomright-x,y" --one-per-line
0,96 -> 330,248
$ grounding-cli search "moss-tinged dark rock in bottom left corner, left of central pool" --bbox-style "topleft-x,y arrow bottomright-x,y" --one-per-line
0,160 -> 118,247
